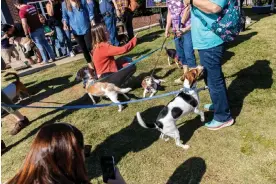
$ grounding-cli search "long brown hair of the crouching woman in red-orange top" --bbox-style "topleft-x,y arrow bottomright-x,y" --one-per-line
91,23 -> 108,50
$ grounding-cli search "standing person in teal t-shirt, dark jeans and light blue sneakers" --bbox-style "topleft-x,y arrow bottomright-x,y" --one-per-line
185,0 -> 234,130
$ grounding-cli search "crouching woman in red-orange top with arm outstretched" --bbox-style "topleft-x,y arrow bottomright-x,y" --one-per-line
91,24 -> 137,86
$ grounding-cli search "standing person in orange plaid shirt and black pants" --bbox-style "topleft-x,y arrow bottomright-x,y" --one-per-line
113,0 -> 134,40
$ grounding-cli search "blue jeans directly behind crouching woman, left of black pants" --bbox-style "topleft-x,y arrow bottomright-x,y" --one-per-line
104,13 -> 119,46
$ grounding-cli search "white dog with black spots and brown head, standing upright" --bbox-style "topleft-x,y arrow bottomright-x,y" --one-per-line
136,66 -> 208,150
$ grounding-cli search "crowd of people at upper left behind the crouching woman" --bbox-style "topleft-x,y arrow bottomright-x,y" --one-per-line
1,0 -> 137,69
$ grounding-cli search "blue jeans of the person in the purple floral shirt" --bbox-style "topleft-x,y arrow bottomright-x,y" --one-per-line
175,31 -> 196,68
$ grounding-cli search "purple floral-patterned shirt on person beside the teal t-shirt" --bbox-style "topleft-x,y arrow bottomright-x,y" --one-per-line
167,0 -> 191,31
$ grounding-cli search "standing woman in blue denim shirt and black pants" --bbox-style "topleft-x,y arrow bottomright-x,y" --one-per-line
62,0 -> 94,69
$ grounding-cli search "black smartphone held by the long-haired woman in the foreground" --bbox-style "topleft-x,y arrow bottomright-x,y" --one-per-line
101,156 -> 115,183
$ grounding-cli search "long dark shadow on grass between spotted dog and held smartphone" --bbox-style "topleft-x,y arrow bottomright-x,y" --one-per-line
86,106 -> 164,179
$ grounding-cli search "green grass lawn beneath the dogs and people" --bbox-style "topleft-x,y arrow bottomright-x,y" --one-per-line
1,12 -> 276,184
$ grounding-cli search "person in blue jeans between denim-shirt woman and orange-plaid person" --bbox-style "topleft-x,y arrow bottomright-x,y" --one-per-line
99,0 -> 120,46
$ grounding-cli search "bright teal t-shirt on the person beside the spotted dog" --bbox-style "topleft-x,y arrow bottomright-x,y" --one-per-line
191,0 -> 228,50
